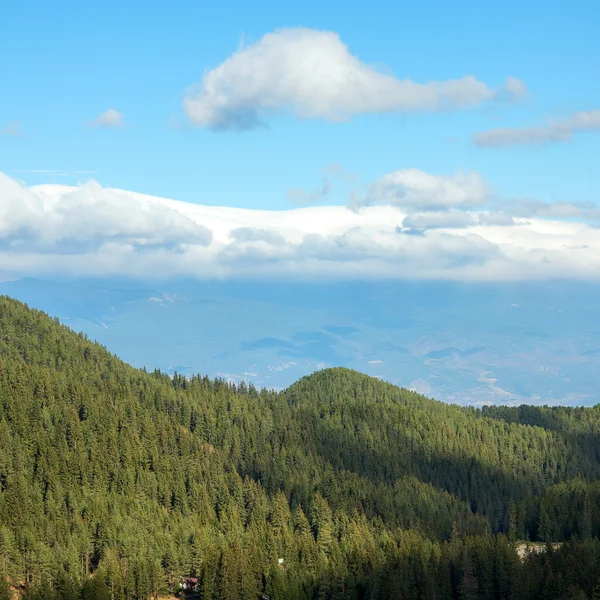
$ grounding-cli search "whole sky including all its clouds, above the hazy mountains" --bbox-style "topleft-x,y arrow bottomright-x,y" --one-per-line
0,0 -> 600,278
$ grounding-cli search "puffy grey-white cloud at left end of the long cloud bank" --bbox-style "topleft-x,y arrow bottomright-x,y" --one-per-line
0,173 -> 212,254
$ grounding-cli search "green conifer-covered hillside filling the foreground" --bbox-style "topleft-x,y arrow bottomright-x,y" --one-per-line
0,297 -> 600,600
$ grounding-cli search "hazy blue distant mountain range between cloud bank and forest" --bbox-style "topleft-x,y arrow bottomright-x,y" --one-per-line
0,278 -> 600,405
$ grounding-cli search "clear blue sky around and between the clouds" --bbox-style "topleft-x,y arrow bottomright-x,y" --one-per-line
0,0 -> 600,209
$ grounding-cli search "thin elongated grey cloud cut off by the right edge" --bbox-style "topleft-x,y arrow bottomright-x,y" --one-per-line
473,109 -> 600,148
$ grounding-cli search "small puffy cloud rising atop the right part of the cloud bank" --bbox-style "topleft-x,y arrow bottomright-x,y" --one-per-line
352,169 -> 490,211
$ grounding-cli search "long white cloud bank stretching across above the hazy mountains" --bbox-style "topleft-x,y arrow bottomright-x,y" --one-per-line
0,171 -> 600,280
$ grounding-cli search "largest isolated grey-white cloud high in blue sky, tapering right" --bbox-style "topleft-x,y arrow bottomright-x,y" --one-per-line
184,27 -> 526,130
